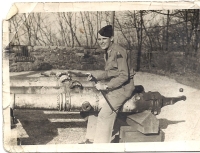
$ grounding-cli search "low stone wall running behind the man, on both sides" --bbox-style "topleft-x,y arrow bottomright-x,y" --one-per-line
9,46 -> 200,73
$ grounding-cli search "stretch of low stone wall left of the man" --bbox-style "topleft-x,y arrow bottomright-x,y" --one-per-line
9,46 -> 104,72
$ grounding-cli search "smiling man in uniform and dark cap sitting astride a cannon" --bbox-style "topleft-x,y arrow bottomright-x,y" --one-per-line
81,25 -> 135,143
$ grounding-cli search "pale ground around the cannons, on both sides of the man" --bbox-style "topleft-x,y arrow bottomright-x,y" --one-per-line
11,72 -> 200,145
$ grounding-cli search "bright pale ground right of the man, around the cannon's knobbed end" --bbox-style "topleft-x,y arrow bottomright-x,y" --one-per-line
135,73 -> 200,142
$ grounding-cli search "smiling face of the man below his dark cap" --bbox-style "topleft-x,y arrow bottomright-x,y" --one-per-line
97,33 -> 113,50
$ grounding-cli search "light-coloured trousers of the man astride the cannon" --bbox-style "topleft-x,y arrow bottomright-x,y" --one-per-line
86,90 -> 128,143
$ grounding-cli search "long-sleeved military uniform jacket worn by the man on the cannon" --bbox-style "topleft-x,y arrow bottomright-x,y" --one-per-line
95,43 -> 134,96
